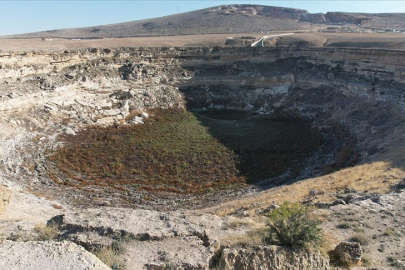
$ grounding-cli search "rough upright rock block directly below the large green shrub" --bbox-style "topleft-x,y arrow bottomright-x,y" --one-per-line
219,246 -> 330,270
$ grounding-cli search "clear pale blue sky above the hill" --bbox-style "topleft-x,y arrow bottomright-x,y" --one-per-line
0,0 -> 405,35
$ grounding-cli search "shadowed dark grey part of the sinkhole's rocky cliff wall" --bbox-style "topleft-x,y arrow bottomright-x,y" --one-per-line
180,48 -> 405,166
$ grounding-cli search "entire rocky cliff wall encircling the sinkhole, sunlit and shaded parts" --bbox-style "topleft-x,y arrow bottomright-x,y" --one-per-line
0,47 -> 405,189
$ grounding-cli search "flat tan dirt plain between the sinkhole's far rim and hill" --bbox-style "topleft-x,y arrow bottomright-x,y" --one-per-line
0,32 -> 405,52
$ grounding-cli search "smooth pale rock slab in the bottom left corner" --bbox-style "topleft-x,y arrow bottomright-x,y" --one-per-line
0,241 -> 110,270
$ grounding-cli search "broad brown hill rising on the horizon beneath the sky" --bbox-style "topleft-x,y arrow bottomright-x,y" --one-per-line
3,5 -> 405,39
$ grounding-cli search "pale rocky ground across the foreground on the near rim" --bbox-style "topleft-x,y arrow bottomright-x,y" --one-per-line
0,182 -> 405,269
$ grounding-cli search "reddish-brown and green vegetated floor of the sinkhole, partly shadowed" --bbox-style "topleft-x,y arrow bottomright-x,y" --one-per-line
48,109 -> 322,194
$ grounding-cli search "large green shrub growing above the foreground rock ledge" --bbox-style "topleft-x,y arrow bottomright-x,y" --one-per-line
265,202 -> 323,248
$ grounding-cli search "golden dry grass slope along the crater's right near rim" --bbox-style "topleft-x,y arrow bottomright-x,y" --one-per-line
208,161 -> 405,216
